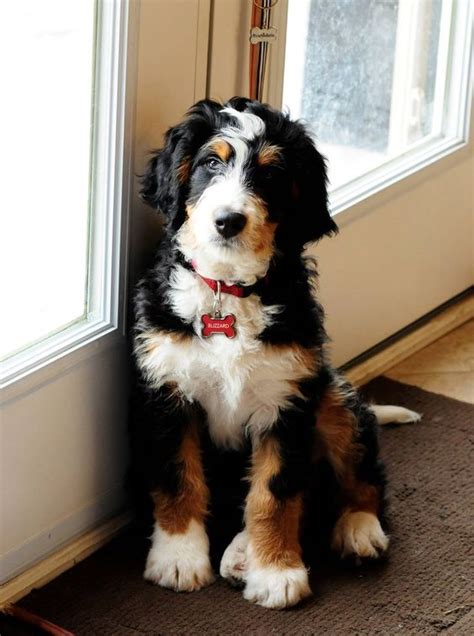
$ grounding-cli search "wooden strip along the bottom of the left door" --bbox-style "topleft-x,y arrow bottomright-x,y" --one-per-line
0,512 -> 132,608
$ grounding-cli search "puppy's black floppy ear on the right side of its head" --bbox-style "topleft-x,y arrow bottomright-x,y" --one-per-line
291,123 -> 338,247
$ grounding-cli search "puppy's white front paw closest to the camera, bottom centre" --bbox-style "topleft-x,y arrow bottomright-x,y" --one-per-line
244,565 -> 311,609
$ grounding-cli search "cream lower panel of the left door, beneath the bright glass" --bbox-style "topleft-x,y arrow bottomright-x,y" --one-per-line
0,344 -> 127,581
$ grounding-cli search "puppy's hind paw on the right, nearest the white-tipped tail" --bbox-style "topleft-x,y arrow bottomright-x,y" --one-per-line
332,511 -> 389,559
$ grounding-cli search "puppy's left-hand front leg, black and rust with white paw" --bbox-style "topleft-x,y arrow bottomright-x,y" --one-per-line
133,386 -> 214,592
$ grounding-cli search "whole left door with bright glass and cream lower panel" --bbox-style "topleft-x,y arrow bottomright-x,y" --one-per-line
0,0 -> 136,583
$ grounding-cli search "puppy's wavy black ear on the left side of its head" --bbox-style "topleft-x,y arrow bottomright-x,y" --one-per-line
140,100 -> 222,229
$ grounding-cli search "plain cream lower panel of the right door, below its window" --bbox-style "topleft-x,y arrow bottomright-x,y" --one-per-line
311,140 -> 474,365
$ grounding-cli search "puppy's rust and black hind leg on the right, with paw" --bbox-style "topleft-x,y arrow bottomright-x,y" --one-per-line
316,378 -> 389,558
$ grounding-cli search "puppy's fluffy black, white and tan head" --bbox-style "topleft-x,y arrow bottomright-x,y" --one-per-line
141,98 -> 337,283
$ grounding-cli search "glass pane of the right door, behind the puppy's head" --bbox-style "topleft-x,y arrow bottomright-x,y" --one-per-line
283,0 -> 451,188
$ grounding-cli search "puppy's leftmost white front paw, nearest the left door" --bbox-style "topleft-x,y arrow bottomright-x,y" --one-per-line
144,521 -> 214,592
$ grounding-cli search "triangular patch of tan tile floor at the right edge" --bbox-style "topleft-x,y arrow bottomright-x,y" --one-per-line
384,320 -> 474,404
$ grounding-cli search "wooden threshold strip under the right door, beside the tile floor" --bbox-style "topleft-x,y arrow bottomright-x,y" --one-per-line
343,295 -> 474,386
